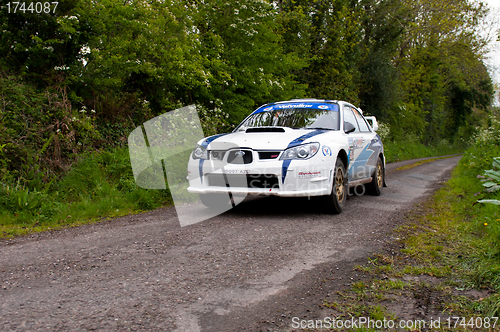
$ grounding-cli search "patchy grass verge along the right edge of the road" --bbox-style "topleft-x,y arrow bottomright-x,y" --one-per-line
323,155 -> 500,331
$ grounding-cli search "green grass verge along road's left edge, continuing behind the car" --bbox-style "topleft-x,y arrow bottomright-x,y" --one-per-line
0,135 -> 466,238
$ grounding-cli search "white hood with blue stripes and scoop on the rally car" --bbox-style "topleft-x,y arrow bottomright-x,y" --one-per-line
199,128 -> 332,150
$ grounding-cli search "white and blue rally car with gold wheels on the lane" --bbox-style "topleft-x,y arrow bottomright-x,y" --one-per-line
187,99 -> 385,213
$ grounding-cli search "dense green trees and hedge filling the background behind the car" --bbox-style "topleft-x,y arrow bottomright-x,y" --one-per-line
0,0 -> 500,231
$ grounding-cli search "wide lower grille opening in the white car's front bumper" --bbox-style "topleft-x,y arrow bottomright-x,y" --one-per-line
207,174 -> 279,189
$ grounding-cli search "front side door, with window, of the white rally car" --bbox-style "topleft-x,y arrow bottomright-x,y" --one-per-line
343,105 -> 369,181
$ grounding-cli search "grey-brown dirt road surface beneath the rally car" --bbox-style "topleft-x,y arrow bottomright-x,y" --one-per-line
0,157 -> 460,331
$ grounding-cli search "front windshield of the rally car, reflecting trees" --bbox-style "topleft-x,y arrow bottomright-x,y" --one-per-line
236,108 -> 340,131
